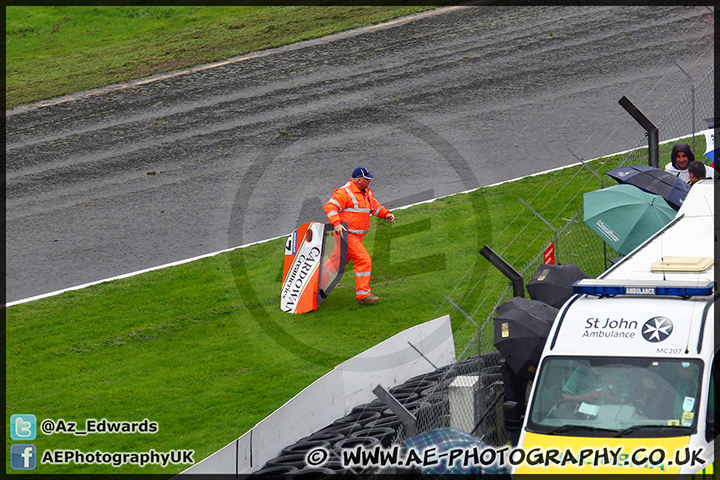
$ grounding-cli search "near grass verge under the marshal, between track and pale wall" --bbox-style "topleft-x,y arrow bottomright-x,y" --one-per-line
6,145 -> 668,473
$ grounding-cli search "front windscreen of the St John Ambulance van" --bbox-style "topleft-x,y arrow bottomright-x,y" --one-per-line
528,357 -> 702,437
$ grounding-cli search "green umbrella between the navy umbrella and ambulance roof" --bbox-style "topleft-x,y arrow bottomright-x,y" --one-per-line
583,184 -> 677,255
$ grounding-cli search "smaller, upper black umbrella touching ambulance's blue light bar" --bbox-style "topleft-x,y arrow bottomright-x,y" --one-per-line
525,263 -> 590,308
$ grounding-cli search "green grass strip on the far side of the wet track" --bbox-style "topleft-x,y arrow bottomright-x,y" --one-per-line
5,3 -> 438,109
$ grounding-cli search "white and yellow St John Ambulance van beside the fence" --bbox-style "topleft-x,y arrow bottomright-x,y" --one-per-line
508,180 -> 720,478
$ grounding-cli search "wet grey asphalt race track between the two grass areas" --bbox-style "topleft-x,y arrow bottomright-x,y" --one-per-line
6,7 -> 714,302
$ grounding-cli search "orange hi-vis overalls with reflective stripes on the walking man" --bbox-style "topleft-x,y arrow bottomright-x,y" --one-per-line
323,181 -> 390,300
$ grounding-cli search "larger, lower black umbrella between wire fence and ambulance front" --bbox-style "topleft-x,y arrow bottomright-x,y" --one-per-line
493,297 -> 558,377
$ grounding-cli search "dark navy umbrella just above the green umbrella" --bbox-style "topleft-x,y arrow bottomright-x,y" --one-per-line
606,165 -> 690,210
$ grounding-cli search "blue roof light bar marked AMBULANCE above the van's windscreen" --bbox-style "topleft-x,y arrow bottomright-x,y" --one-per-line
573,278 -> 715,298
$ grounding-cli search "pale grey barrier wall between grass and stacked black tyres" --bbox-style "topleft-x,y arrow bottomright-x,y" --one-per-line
181,315 -> 455,475
